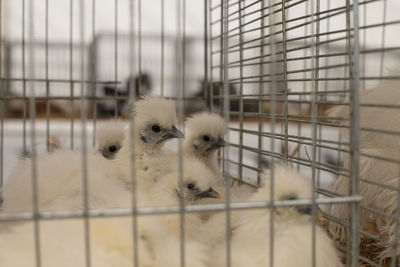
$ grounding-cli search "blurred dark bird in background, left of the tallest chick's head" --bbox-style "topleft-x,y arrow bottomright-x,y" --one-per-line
97,73 -> 152,117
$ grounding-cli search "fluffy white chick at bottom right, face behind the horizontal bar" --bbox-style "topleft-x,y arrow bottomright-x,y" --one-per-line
211,166 -> 342,267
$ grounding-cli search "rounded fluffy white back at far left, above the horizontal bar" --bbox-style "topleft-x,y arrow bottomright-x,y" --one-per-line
2,150 -> 138,212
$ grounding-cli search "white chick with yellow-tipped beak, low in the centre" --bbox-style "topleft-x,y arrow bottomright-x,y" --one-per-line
149,159 -> 220,242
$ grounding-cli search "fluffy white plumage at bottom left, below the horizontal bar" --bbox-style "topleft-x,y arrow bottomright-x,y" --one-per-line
0,206 -> 207,267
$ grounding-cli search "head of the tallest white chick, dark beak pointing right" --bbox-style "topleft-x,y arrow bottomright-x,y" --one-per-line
135,97 -> 184,151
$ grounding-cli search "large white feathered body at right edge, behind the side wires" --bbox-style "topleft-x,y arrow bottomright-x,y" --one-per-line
329,73 -> 400,259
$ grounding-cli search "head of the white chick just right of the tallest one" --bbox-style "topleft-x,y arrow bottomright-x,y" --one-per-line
185,112 -> 225,158
